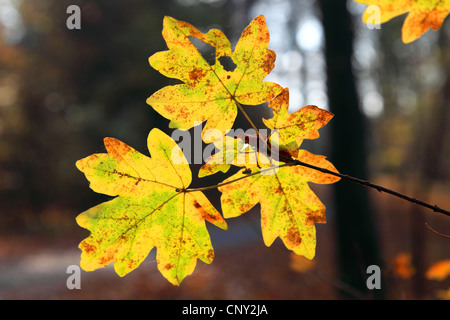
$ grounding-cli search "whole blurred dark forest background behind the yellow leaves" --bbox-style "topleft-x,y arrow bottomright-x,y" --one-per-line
0,0 -> 450,299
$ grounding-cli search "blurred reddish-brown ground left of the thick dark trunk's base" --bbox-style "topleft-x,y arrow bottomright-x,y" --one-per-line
0,215 -> 340,299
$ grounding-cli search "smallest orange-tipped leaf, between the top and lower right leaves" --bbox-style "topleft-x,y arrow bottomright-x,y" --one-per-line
199,88 -> 333,177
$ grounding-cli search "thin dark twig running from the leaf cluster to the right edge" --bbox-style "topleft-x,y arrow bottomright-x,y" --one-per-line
235,100 -> 450,217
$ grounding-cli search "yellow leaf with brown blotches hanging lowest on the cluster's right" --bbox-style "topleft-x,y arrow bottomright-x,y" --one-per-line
219,150 -> 339,259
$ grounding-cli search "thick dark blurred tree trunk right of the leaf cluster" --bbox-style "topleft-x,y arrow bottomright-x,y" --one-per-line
319,0 -> 383,297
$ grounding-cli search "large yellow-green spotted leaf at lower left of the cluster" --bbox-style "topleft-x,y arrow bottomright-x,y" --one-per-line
76,129 -> 227,285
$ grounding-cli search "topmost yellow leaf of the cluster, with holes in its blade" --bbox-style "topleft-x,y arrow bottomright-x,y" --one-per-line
147,16 -> 282,143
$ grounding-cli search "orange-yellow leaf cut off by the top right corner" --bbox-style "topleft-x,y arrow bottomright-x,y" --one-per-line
355,0 -> 450,43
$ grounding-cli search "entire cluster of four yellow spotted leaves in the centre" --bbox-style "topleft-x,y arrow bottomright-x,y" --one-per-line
76,16 -> 339,285
